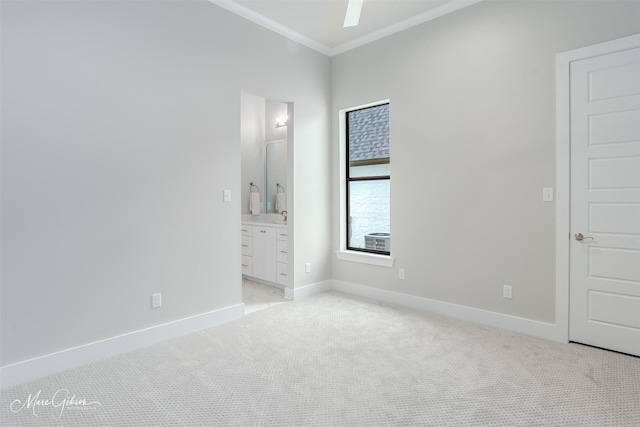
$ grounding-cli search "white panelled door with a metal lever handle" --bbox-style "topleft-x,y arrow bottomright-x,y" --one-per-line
569,48 -> 640,356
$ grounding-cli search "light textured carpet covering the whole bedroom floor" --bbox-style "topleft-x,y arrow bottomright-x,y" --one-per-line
0,292 -> 640,426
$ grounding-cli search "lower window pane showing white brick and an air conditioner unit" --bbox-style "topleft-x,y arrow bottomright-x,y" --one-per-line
348,179 -> 391,252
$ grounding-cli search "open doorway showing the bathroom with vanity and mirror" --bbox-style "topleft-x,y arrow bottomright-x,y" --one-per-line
240,91 -> 293,314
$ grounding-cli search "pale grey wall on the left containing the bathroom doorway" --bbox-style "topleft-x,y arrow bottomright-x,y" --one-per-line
0,1 -> 330,366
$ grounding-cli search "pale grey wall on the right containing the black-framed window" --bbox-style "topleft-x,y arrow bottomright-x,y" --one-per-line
331,1 -> 640,323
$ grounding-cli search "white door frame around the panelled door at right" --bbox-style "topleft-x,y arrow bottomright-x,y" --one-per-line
555,34 -> 640,342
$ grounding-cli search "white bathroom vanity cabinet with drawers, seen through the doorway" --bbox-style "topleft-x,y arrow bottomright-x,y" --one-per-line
241,215 -> 289,288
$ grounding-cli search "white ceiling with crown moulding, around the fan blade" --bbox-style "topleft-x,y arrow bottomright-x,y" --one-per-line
209,0 -> 481,56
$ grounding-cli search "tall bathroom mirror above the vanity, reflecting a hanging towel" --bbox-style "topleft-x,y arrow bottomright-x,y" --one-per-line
264,139 -> 287,213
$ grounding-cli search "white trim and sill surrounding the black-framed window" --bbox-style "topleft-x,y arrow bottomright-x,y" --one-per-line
336,99 -> 395,267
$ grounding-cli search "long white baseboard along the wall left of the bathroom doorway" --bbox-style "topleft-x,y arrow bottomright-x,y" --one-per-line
0,304 -> 244,389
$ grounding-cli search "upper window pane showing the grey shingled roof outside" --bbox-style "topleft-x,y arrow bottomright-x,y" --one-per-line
347,104 -> 389,177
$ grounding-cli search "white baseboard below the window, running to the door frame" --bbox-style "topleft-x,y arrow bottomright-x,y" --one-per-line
325,280 -> 567,342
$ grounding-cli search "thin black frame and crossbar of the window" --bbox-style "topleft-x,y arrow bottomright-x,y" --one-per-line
344,101 -> 391,257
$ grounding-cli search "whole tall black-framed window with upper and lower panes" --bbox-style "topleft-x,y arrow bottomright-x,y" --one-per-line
345,103 -> 391,255
